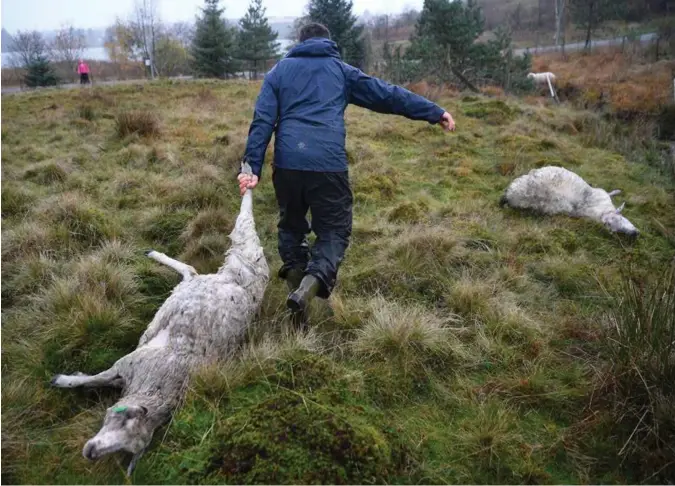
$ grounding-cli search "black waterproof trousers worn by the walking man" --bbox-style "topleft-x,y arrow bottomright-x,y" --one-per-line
272,168 -> 353,299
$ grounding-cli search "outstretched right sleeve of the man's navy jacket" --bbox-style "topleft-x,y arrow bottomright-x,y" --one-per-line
345,65 -> 445,124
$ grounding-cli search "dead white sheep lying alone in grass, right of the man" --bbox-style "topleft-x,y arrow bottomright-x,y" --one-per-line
500,167 -> 640,238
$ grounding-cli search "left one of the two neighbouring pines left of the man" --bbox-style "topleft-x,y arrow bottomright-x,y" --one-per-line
192,0 -> 236,78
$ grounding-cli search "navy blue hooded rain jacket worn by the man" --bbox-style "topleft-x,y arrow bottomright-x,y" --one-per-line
245,37 -> 445,176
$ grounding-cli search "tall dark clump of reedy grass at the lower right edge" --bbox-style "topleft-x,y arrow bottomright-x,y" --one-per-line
598,262 -> 675,482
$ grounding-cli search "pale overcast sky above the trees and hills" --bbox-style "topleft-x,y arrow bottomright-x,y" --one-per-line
1,0 -> 423,33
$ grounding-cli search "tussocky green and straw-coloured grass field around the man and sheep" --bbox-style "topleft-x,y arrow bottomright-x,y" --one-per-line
2,82 -> 675,484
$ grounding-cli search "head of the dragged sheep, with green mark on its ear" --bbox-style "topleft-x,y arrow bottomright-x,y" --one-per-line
82,403 -> 154,468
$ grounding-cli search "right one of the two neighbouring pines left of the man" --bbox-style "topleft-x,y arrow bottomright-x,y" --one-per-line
237,0 -> 279,79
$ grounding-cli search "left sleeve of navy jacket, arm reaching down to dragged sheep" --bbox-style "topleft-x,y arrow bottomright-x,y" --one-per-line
244,69 -> 279,177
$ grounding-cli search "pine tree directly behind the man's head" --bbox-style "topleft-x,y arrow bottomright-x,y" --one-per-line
308,0 -> 366,68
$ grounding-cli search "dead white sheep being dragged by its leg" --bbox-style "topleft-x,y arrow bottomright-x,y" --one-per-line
52,163 -> 269,474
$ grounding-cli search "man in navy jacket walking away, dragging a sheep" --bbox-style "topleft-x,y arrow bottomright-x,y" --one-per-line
238,24 -> 455,312
